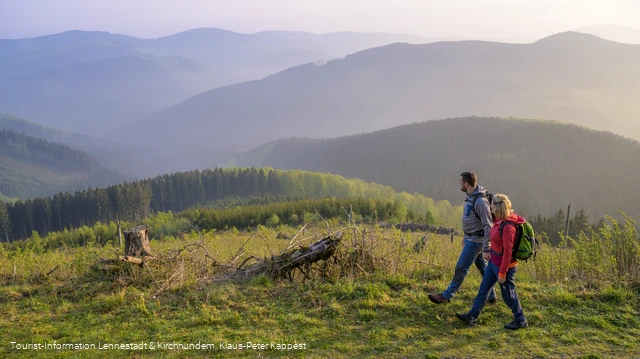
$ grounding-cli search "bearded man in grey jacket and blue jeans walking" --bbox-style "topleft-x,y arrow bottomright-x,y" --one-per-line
429,172 -> 496,304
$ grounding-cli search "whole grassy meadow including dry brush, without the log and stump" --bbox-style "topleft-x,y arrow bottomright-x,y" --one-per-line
0,223 -> 640,358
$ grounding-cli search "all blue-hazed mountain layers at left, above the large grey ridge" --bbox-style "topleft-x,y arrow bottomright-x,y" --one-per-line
0,29 -> 448,136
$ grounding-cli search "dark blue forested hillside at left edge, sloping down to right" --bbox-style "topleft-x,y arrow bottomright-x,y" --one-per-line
0,129 -> 130,198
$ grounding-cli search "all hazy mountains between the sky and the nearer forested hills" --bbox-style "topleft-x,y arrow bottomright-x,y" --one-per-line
0,28 -> 640,183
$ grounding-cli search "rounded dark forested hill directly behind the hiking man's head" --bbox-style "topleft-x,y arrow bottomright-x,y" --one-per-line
230,117 -> 640,218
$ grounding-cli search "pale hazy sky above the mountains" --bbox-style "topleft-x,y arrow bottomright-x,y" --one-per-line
0,0 -> 640,41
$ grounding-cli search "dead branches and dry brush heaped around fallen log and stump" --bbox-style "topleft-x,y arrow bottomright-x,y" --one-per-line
94,210 -> 410,296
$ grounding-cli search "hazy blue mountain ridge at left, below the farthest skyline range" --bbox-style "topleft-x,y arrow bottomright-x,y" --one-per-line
0,57 -> 198,136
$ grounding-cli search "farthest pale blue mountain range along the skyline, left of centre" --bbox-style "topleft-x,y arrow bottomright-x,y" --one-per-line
0,28 -> 462,79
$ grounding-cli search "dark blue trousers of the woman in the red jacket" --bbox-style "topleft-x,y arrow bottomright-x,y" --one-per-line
469,262 -> 526,323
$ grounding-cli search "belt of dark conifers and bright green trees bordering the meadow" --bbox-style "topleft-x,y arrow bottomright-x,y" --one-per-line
0,168 -> 462,240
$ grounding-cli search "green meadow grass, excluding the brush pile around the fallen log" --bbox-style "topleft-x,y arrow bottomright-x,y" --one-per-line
0,229 -> 640,358
